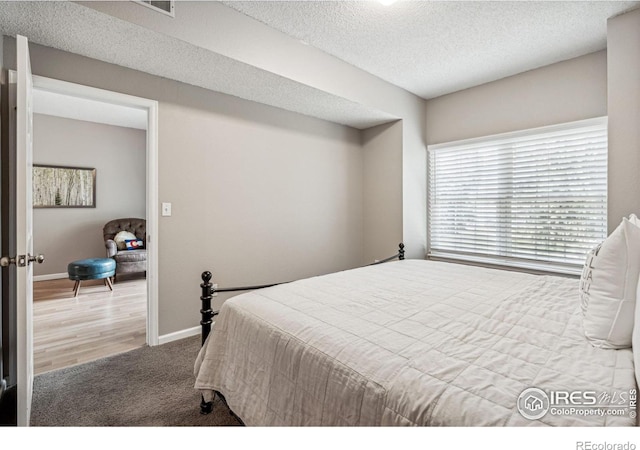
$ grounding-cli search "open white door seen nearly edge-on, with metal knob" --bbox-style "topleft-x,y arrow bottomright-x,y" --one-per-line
15,36 -> 35,426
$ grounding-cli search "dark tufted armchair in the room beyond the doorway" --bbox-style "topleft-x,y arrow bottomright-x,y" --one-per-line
102,218 -> 147,281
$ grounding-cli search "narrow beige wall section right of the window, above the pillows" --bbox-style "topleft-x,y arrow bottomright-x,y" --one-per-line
607,9 -> 640,231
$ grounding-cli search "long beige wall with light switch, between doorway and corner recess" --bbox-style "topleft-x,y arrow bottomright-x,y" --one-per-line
5,39 -> 363,336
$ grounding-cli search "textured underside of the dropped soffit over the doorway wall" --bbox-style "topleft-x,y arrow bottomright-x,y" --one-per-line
0,1 -> 398,129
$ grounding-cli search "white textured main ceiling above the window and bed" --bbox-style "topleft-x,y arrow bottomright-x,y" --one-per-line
223,1 -> 640,98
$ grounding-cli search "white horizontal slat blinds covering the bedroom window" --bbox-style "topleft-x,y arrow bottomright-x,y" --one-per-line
428,117 -> 607,273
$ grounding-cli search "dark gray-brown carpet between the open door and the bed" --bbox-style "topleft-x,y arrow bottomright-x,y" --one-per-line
31,337 -> 239,427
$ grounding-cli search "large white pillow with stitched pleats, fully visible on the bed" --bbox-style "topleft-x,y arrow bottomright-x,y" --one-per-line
580,216 -> 640,348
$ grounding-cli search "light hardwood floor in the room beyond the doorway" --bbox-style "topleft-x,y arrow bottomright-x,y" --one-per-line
33,278 -> 147,374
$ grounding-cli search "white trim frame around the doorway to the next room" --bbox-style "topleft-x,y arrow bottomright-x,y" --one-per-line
33,75 -> 159,346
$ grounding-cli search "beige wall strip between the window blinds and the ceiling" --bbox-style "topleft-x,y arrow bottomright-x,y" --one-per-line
426,50 -> 607,145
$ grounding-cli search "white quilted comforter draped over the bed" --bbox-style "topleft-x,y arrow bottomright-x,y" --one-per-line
195,260 -> 636,426
